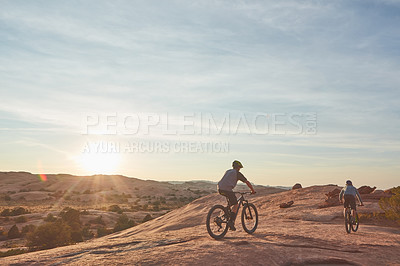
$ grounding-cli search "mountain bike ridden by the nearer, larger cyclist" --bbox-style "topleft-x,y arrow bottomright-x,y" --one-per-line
206,192 -> 258,239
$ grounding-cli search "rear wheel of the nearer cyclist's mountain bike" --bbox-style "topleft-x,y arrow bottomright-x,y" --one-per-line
206,205 -> 229,239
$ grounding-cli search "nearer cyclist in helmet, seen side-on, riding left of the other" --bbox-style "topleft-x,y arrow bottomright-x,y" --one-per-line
218,161 -> 256,231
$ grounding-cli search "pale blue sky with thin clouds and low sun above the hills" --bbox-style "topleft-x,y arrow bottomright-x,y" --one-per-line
0,0 -> 400,189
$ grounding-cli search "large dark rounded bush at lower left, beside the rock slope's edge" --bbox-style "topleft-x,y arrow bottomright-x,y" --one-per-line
27,220 -> 73,250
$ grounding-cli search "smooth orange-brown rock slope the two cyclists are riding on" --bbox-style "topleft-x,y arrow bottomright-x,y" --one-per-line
2,186 -> 400,265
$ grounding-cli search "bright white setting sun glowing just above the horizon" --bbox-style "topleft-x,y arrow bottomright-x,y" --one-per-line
76,153 -> 121,174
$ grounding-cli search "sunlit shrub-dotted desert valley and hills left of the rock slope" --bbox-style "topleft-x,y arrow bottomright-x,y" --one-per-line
0,172 -> 215,256
